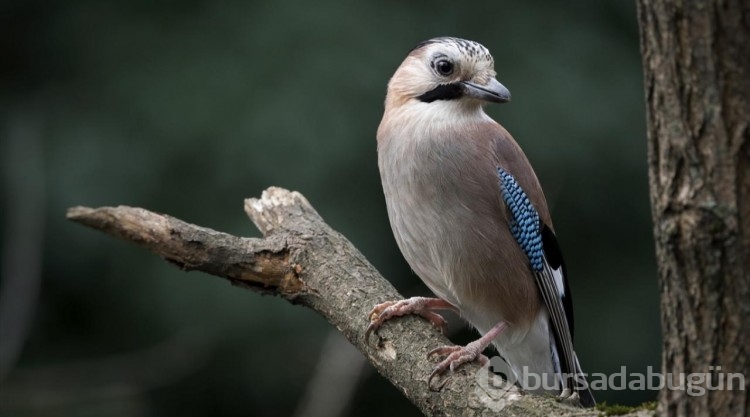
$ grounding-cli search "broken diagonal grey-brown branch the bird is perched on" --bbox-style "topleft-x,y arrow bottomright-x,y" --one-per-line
68,188 -> 648,416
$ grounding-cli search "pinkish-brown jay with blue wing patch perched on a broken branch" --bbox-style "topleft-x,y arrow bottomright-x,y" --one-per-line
365,37 -> 595,407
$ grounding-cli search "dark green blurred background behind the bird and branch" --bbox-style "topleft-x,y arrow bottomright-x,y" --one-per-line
0,0 -> 660,416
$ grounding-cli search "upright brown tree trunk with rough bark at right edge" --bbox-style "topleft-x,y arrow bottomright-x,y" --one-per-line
637,0 -> 750,416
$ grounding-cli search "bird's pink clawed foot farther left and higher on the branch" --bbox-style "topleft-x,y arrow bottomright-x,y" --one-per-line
365,297 -> 458,340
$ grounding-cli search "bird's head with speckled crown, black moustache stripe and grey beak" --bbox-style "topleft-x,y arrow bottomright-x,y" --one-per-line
386,37 -> 510,108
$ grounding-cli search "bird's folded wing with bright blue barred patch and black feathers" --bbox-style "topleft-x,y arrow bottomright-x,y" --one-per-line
497,167 -> 593,401
